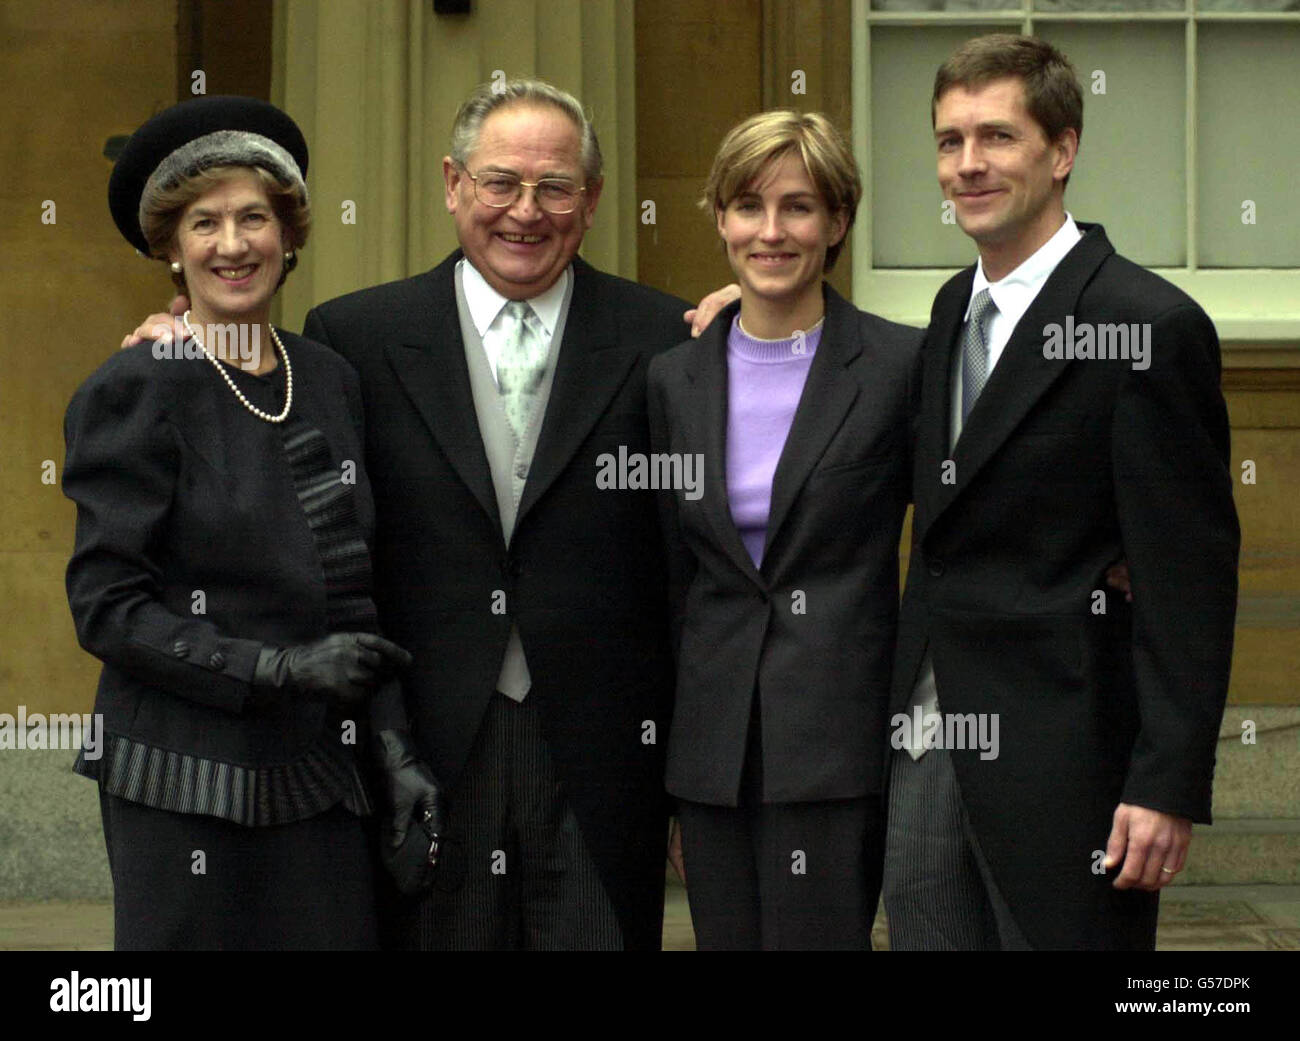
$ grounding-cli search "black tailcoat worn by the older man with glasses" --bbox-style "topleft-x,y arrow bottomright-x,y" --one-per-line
306,252 -> 685,949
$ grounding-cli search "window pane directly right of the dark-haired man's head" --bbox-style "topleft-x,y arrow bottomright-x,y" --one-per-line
1039,22 -> 1185,268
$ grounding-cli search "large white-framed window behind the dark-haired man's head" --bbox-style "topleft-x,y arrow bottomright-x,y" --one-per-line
853,0 -> 1300,341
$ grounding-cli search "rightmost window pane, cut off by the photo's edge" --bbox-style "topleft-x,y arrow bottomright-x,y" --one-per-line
1196,22 -> 1300,268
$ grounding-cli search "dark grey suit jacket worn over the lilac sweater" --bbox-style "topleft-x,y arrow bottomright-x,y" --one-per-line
650,286 -> 922,806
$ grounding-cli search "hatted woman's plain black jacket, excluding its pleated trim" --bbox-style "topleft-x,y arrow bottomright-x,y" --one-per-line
64,333 -> 373,767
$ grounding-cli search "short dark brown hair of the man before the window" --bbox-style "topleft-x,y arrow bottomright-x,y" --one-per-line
930,32 -> 1083,148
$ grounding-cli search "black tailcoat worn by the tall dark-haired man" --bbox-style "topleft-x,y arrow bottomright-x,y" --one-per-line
893,225 -> 1240,947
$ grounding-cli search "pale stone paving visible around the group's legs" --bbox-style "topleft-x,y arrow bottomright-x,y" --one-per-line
0,885 -> 1300,950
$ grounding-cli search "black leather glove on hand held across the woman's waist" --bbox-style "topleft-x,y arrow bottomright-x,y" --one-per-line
252,633 -> 412,704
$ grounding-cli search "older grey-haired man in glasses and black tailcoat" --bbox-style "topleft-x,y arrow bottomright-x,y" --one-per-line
306,82 -> 685,950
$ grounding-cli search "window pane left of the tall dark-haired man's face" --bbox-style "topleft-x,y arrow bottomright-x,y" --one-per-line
859,26 -> 1000,268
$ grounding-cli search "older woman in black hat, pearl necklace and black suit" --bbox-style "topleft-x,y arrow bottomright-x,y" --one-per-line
64,97 -> 439,949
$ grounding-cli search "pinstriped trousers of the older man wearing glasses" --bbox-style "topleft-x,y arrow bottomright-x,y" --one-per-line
413,694 -> 623,950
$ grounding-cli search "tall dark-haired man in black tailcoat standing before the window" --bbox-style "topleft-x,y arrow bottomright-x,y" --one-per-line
884,35 -> 1240,949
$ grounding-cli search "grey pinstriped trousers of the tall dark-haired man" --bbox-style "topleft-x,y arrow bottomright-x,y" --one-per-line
884,749 -> 1032,950
